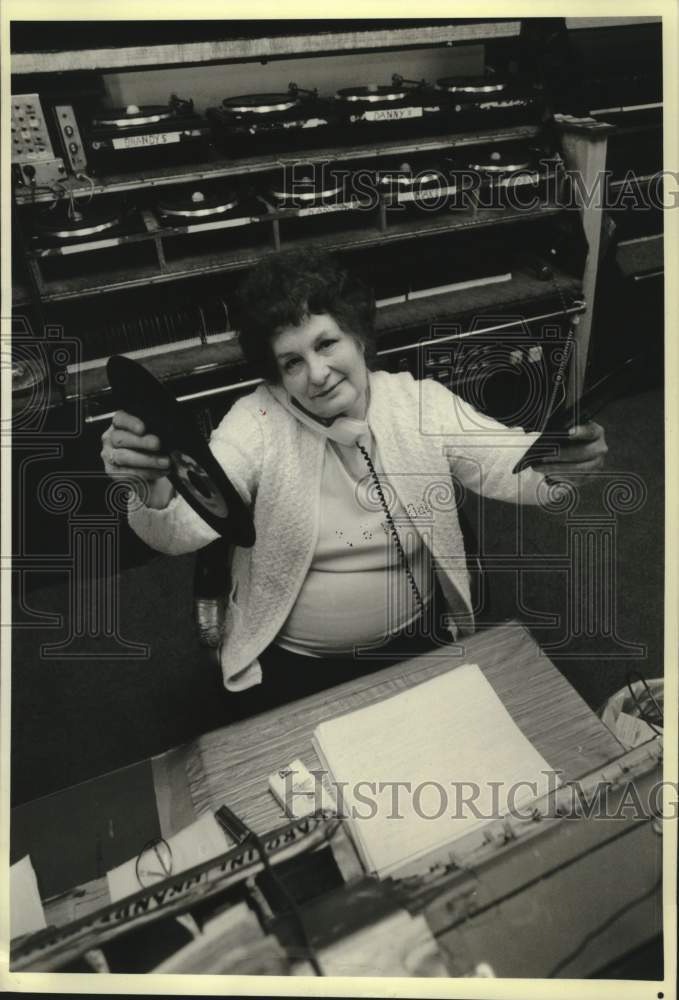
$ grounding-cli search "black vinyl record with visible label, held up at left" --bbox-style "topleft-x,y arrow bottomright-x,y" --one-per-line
106,355 -> 255,548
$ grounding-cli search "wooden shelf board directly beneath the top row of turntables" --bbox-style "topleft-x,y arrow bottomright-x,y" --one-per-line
16,125 -> 539,205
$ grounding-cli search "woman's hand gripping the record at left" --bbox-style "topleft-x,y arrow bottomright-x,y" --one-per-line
101,410 -> 174,507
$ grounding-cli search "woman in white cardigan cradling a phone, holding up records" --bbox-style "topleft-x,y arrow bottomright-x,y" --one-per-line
102,250 -> 606,711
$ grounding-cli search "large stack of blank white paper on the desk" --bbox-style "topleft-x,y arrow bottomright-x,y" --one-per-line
314,664 -> 554,875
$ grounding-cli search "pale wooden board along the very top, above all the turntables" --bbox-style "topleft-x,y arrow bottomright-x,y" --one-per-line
11,19 -> 521,74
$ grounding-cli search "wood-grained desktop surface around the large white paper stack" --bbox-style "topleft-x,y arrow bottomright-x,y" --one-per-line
183,622 -> 623,833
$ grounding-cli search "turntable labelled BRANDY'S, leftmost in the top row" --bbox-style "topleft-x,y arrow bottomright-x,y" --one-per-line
84,94 -> 209,170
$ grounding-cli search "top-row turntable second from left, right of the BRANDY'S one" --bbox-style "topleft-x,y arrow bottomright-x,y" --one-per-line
206,83 -> 333,155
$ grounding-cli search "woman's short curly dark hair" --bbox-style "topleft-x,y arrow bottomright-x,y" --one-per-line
237,249 -> 375,382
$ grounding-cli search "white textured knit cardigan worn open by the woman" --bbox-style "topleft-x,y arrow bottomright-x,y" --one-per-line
129,372 -> 543,691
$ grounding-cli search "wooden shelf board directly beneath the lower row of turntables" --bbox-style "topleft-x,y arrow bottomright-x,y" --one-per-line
35,205 -> 563,302
